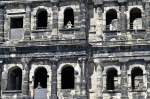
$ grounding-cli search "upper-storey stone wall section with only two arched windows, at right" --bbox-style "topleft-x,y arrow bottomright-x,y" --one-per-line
89,0 -> 150,46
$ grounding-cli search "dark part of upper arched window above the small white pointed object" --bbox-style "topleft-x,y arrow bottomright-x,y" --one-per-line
64,7 -> 74,26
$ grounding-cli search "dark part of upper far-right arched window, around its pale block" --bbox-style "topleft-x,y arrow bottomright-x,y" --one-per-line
130,8 -> 142,29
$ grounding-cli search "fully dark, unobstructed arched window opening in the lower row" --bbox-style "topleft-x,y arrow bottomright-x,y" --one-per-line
61,66 -> 75,89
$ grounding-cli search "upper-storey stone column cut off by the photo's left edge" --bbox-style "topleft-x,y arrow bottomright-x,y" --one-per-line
0,5 -> 4,42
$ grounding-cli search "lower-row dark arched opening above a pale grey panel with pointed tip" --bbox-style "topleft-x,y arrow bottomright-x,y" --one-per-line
34,67 -> 48,88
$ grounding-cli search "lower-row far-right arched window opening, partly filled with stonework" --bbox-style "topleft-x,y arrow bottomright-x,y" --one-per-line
131,67 -> 143,89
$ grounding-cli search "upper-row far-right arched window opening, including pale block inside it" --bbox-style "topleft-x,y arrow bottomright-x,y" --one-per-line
130,8 -> 142,29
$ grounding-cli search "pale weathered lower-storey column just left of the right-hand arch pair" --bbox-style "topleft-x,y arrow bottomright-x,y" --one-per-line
94,59 -> 103,99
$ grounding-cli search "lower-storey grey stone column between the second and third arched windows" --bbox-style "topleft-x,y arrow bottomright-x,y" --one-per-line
51,59 -> 58,99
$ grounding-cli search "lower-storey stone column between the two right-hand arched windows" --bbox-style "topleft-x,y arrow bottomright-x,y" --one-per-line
121,63 -> 129,99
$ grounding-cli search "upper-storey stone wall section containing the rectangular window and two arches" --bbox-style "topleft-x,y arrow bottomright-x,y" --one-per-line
1,0 -> 87,45
